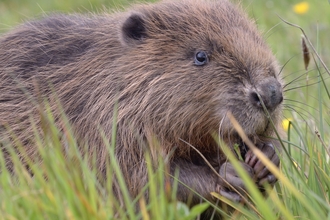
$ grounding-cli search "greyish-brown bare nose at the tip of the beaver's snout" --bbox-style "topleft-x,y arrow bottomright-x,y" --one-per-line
250,78 -> 283,112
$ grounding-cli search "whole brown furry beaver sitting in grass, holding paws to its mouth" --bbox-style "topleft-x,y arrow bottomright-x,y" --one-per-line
0,0 -> 283,217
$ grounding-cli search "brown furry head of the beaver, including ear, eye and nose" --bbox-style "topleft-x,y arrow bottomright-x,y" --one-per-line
114,0 -> 283,152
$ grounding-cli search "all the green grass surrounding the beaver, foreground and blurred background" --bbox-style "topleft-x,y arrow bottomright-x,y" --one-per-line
0,0 -> 330,219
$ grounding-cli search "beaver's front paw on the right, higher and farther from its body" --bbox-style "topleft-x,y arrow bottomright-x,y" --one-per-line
245,142 -> 280,186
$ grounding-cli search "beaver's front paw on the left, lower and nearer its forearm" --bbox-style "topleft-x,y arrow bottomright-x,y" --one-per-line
217,162 -> 254,202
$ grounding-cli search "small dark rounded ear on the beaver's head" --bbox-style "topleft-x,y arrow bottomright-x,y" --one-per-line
121,13 -> 147,44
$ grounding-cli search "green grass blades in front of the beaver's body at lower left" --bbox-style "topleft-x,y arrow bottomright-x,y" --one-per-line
0,103 -> 209,220
